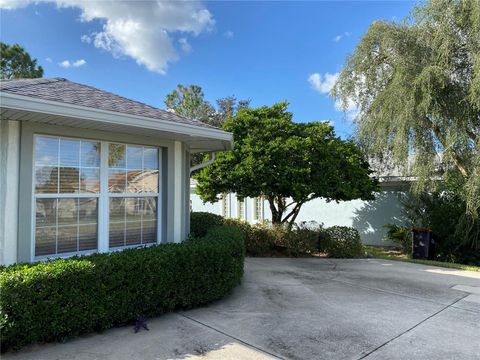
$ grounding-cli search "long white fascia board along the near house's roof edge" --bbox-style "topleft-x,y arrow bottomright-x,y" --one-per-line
0,91 -> 233,149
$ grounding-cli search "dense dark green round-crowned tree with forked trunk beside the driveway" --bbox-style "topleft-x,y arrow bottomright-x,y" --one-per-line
196,102 -> 377,225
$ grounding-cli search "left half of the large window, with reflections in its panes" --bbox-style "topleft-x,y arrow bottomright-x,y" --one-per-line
34,136 -> 100,256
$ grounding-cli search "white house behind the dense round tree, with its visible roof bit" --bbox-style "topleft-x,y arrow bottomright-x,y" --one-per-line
190,170 -> 412,246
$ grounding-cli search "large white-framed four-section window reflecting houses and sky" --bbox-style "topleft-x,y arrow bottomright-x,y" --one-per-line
34,135 -> 159,257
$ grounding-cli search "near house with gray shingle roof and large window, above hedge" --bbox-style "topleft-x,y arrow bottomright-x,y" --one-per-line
0,78 -> 233,264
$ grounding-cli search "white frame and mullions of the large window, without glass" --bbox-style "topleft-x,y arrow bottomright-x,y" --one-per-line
30,133 -> 164,261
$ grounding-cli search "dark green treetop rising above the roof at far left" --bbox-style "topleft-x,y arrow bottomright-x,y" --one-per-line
0,42 -> 43,79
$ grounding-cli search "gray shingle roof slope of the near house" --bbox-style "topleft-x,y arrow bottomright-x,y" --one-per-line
0,78 -> 215,129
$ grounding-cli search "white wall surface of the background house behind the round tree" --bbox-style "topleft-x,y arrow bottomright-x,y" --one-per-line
190,189 -> 405,245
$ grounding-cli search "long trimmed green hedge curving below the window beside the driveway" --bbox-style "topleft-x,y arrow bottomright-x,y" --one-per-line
0,226 -> 245,351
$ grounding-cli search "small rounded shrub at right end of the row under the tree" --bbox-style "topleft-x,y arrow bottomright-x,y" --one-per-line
320,226 -> 363,258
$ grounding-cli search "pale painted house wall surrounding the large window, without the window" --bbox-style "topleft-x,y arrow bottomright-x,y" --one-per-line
0,119 -> 190,265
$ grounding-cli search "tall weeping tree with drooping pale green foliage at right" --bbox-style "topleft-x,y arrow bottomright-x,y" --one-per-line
332,0 -> 480,218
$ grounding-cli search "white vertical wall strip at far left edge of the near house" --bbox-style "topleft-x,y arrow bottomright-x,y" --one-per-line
0,120 -> 20,265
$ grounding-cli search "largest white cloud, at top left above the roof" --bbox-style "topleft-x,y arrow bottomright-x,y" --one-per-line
0,0 -> 215,74
